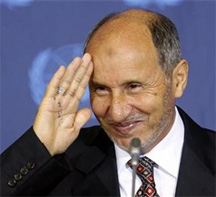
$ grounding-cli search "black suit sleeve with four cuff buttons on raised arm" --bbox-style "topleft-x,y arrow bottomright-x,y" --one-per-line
1,128 -> 70,196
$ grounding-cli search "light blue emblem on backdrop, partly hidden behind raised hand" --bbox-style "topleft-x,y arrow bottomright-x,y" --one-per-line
29,44 -> 89,105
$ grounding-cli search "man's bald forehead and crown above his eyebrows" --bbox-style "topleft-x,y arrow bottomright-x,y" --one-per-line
86,9 -> 158,82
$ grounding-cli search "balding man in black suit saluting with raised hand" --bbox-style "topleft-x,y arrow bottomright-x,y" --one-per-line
1,9 -> 215,197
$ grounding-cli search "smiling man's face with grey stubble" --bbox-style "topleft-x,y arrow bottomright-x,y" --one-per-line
87,24 -> 174,151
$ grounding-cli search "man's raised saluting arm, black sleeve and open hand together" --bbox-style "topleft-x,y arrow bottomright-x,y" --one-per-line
1,54 -> 93,196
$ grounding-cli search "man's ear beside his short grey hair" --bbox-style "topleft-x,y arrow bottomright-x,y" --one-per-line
172,59 -> 188,98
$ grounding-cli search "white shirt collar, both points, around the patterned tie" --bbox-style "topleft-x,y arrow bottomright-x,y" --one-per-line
114,108 -> 184,178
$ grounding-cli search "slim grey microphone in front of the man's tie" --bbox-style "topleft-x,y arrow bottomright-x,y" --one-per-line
129,138 -> 141,197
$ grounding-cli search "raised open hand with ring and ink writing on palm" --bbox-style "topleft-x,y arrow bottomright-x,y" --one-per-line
33,53 -> 93,155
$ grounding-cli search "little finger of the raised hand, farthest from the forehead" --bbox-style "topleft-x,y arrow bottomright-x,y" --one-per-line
45,66 -> 66,97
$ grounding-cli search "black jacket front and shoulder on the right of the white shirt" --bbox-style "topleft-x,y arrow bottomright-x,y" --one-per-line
176,109 -> 215,196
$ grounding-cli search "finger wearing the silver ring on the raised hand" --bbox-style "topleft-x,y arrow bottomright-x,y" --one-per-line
58,57 -> 82,94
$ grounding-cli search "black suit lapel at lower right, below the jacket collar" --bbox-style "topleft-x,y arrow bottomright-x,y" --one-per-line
176,142 -> 215,196
